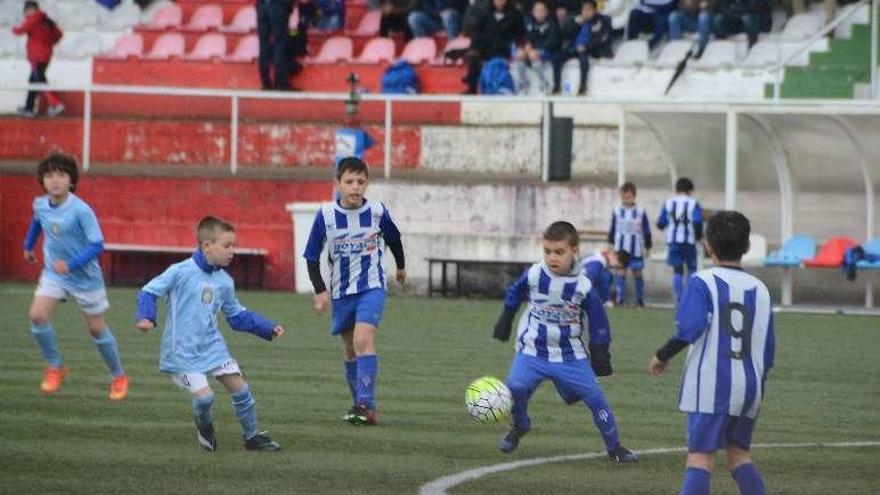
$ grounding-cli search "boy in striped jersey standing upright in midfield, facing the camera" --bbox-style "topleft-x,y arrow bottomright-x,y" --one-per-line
303,157 -> 406,425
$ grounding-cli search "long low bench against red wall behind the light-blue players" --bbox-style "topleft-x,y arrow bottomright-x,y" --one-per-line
102,244 -> 269,289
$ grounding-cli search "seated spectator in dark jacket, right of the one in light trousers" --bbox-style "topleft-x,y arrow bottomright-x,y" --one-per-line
553,0 -> 614,94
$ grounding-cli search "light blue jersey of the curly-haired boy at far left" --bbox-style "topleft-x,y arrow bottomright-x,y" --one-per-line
33,193 -> 104,292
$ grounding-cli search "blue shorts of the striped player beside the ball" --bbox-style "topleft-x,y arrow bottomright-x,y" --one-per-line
507,352 -> 601,404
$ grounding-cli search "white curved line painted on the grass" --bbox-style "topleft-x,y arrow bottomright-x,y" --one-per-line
419,441 -> 880,495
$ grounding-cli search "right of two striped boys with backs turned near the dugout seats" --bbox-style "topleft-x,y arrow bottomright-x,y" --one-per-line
657,177 -> 703,304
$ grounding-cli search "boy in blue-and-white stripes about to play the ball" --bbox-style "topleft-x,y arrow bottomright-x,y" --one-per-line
494,222 -> 638,463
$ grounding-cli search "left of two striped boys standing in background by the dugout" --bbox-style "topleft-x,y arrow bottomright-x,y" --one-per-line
608,182 -> 651,306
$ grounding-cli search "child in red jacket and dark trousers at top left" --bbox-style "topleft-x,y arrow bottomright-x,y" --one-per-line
12,0 -> 64,117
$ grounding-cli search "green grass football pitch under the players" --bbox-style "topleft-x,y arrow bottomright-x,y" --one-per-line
0,284 -> 880,494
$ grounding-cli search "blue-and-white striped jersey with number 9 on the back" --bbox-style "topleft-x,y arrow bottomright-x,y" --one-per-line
675,267 -> 776,418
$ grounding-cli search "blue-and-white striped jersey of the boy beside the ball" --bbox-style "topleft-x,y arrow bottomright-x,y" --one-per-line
504,262 -> 611,363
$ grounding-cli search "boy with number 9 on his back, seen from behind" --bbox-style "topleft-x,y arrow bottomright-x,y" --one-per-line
649,211 -> 776,495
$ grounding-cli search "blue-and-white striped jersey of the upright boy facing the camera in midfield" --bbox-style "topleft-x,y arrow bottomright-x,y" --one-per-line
303,200 -> 400,299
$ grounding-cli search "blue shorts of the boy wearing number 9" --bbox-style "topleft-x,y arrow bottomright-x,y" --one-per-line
687,413 -> 755,452
